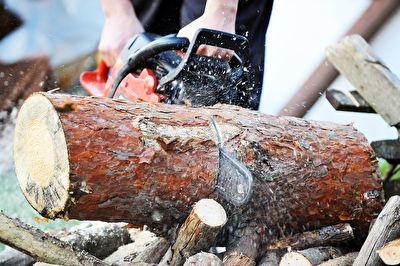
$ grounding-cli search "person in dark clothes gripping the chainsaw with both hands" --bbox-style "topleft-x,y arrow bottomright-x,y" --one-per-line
98,0 -> 273,110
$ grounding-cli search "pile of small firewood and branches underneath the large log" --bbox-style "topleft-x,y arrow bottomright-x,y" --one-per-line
0,196 -> 400,266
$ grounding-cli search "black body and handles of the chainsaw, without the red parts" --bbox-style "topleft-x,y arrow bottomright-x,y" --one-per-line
110,29 -> 253,107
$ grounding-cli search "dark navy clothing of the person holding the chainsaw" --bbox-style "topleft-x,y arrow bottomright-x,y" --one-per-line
132,0 -> 273,110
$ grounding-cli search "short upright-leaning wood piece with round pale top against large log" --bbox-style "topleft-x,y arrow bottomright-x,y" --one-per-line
169,199 -> 227,266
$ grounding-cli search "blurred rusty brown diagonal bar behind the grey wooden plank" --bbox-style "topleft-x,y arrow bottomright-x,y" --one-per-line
278,0 -> 400,117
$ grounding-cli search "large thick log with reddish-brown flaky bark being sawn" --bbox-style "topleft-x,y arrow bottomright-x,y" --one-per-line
14,93 -> 383,238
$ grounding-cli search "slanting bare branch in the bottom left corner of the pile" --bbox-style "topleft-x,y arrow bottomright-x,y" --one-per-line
0,211 -> 107,266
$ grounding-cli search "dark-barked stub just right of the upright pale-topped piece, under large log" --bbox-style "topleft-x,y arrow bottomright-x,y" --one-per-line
223,223 -> 264,266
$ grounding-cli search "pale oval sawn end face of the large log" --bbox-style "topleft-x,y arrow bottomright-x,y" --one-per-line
14,94 -> 70,218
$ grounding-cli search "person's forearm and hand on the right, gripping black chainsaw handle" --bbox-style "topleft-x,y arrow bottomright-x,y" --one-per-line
177,0 -> 239,59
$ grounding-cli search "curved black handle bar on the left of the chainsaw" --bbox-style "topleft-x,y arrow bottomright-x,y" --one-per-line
108,35 -> 190,98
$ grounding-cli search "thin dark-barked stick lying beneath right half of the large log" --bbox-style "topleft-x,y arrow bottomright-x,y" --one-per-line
262,223 -> 354,252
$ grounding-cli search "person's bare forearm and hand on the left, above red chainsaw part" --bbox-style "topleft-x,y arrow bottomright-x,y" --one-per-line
98,0 -> 144,67
